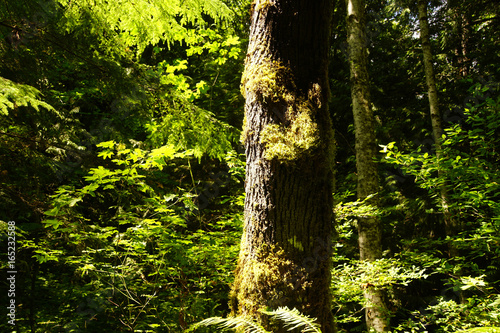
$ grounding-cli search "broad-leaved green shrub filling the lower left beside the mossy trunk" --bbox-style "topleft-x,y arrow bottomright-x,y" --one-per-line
23,142 -> 240,330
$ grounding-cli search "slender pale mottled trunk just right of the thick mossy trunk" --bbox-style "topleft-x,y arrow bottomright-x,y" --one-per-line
346,0 -> 389,332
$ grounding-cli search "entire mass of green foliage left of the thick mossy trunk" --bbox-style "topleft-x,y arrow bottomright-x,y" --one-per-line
0,0 -> 249,332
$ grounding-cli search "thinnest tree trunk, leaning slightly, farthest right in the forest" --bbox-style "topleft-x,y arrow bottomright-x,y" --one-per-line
417,0 -> 458,257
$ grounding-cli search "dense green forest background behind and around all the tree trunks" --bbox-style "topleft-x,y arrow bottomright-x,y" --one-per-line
0,0 -> 500,332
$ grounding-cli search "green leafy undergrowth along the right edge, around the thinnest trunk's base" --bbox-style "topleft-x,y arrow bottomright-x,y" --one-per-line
383,84 -> 500,332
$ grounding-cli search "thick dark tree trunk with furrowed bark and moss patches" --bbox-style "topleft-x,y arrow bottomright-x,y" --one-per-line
231,0 -> 334,333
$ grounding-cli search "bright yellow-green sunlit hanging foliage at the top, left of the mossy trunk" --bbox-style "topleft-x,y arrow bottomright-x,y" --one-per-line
54,0 -> 231,55
